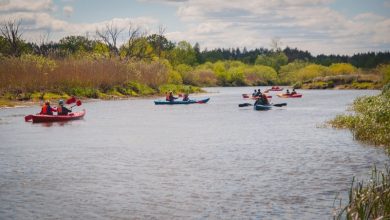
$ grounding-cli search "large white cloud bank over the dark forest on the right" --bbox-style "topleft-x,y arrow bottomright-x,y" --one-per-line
161,0 -> 390,54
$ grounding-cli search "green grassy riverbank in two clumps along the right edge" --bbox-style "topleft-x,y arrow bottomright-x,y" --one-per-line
329,83 -> 390,219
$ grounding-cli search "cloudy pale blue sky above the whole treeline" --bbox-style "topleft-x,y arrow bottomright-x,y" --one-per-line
0,0 -> 390,55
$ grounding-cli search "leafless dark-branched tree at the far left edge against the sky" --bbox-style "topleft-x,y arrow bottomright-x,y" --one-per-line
0,20 -> 22,56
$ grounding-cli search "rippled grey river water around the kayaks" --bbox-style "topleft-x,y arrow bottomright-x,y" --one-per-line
0,87 -> 389,219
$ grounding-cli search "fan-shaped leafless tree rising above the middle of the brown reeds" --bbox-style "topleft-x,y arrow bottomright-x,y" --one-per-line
96,23 -> 123,54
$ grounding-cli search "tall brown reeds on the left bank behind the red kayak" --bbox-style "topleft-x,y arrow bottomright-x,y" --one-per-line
0,55 -> 168,98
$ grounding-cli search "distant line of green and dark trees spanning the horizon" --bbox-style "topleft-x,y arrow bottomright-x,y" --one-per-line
0,34 -> 390,69
